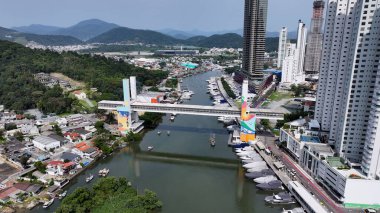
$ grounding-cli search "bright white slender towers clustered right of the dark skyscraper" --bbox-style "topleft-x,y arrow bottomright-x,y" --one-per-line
281,21 -> 307,85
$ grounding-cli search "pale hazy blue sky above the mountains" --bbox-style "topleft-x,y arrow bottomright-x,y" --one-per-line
0,0 -> 313,31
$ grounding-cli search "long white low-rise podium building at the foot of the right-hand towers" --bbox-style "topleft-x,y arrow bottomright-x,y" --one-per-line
299,144 -> 380,208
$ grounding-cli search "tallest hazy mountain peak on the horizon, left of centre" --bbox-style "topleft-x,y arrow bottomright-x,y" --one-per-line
51,19 -> 119,41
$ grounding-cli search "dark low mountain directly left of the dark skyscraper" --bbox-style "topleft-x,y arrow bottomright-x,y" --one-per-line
187,33 -> 243,48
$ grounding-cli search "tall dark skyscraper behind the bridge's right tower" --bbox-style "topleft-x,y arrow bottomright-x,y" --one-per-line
242,0 -> 268,81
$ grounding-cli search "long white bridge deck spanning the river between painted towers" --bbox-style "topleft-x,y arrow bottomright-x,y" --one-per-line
98,101 -> 283,120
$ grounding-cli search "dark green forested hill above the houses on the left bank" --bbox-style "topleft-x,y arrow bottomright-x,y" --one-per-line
0,41 -> 167,112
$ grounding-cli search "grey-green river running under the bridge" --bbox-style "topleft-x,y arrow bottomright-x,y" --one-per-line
31,71 -> 283,213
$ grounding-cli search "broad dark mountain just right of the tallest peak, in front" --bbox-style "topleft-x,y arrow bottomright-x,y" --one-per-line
88,27 -> 183,45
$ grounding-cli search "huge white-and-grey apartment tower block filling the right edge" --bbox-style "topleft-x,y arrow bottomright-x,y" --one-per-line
315,0 -> 380,178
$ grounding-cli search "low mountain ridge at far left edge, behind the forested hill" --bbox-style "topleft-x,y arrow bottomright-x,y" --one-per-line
0,27 -> 83,46
